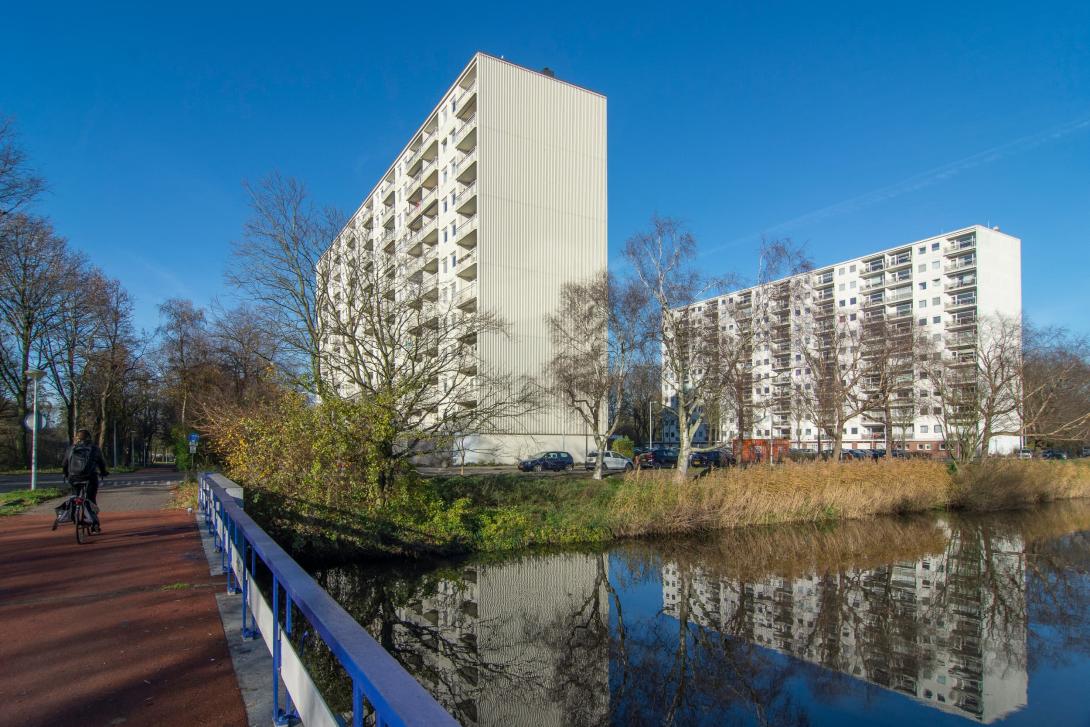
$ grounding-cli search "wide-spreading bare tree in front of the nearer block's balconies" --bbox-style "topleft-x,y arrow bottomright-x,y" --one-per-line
316,226 -> 538,493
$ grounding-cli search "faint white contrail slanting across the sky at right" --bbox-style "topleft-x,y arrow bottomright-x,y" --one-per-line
701,109 -> 1090,256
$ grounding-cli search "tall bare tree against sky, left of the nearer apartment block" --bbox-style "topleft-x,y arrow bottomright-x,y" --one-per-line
227,173 -> 343,392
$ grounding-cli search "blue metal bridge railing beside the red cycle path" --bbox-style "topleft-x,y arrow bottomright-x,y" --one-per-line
199,474 -> 458,727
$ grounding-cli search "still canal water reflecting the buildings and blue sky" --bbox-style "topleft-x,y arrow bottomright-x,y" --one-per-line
307,501 -> 1090,726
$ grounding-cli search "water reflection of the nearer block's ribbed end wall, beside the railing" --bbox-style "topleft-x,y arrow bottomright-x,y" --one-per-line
398,555 -> 609,727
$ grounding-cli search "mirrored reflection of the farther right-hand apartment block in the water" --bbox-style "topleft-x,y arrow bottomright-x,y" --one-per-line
662,529 -> 1028,724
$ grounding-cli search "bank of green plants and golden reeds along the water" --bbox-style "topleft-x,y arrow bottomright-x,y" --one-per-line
236,460 -> 1090,562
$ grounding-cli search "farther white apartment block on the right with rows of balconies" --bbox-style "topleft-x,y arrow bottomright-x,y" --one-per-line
663,225 -> 1021,456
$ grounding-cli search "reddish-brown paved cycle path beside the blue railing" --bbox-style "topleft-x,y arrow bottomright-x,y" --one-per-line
0,483 -> 246,727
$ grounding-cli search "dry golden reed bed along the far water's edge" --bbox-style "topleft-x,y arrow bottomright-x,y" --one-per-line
610,460 -> 1090,535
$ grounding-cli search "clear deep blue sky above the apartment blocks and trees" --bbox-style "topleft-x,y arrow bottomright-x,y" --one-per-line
0,1 -> 1090,332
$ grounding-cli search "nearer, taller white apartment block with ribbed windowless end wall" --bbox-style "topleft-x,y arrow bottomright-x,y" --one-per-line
322,52 -> 607,462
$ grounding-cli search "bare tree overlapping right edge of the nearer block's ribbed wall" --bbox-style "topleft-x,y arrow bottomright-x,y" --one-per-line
545,272 -> 649,480
